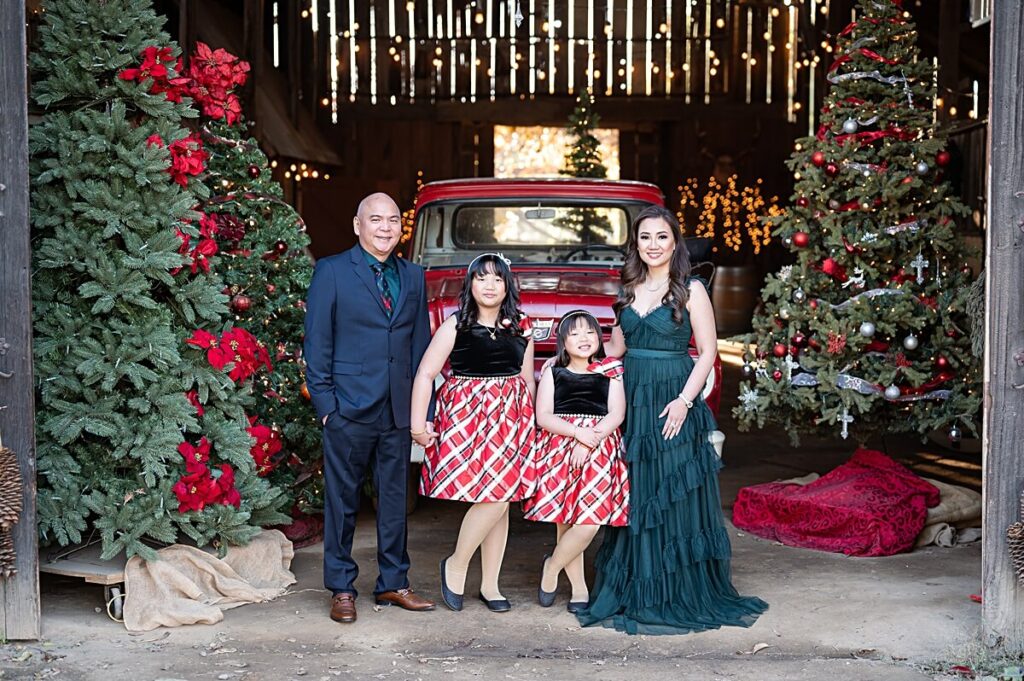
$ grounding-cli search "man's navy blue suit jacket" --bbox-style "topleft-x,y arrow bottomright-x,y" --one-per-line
304,246 -> 430,428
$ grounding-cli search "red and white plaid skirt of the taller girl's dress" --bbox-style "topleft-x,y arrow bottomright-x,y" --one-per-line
420,375 -> 537,503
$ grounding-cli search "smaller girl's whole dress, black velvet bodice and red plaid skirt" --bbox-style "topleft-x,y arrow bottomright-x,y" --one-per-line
523,360 -> 630,526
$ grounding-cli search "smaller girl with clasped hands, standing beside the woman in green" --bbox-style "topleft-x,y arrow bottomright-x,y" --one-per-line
523,310 -> 630,612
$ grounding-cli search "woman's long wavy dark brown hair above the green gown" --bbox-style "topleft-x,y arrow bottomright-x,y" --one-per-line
611,201 -> 690,324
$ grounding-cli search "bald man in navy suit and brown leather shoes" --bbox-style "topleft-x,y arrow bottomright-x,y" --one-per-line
305,194 -> 434,623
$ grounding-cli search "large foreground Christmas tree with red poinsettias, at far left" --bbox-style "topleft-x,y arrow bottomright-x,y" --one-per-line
30,0 -> 287,558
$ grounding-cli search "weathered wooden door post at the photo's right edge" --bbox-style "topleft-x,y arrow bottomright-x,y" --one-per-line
982,2 -> 1024,653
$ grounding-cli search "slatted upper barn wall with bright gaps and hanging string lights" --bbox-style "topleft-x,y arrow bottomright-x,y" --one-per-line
294,0 -> 839,111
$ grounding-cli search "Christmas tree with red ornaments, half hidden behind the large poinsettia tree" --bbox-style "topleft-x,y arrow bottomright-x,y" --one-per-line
188,43 -> 322,507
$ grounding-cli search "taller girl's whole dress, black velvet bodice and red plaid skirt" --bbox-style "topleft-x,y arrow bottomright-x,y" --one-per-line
420,321 -> 537,503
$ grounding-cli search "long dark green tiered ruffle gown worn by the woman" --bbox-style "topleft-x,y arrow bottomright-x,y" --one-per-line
577,305 -> 768,634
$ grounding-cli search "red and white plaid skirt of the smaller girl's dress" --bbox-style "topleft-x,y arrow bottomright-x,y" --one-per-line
522,414 -> 630,526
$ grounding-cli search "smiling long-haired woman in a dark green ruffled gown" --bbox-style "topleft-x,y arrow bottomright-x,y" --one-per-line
577,206 -> 768,634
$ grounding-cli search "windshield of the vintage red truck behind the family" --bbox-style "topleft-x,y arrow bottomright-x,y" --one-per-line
414,202 -> 631,266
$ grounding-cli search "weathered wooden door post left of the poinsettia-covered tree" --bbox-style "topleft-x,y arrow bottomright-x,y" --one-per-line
0,2 -> 40,640
